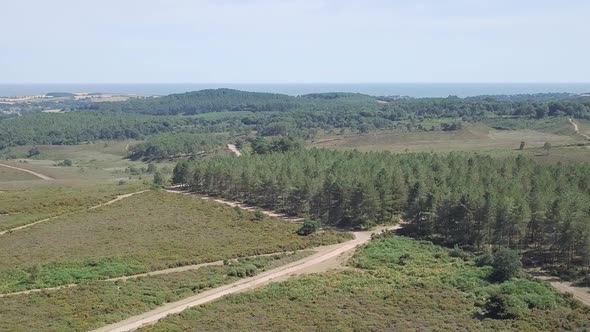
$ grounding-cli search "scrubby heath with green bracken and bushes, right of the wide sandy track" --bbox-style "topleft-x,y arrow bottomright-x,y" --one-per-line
142,236 -> 590,331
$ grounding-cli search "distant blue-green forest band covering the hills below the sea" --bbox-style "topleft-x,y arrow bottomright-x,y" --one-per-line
0,89 -> 590,149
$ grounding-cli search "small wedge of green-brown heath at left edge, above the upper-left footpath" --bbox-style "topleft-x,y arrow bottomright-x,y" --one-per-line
0,182 -> 146,231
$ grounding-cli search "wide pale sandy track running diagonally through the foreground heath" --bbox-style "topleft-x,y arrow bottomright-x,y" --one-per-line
95,226 -> 399,332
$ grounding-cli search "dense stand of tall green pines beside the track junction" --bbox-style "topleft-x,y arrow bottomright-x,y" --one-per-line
173,149 -> 590,266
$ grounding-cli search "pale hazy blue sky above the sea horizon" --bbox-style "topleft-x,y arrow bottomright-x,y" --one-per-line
0,0 -> 590,83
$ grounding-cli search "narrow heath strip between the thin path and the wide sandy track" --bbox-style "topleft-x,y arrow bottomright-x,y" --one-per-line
0,252 -> 310,331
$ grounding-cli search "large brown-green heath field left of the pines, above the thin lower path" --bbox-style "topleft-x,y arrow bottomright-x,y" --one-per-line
0,191 -> 350,292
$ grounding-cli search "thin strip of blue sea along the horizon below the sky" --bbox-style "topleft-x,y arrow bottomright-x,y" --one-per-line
0,83 -> 590,97
